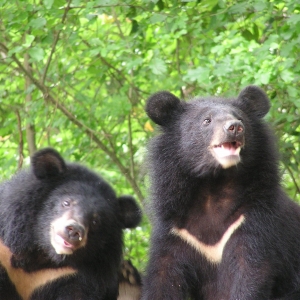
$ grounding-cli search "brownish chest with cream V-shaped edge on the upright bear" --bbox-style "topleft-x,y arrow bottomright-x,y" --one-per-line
172,188 -> 245,263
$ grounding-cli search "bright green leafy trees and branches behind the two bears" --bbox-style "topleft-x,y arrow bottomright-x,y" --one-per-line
0,0 -> 300,269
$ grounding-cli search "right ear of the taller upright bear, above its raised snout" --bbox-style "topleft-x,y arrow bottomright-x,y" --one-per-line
237,85 -> 271,118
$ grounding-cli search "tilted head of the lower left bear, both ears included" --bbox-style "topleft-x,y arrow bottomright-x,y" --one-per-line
4,148 -> 141,262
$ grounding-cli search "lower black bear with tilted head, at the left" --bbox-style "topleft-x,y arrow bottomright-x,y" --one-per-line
0,148 -> 141,300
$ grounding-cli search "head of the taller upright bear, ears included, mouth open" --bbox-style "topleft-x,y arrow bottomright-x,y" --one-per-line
146,86 -> 270,175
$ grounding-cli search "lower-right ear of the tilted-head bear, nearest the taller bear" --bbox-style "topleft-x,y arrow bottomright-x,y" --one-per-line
118,196 -> 142,228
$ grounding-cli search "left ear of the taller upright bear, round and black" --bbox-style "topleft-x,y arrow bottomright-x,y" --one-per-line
145,91 -> 181,126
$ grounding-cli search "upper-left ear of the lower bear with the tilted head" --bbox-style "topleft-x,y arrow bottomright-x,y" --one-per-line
31,148 -> 66,179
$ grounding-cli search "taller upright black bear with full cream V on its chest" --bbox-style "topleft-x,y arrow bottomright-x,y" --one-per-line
142,86 -> 300,300
